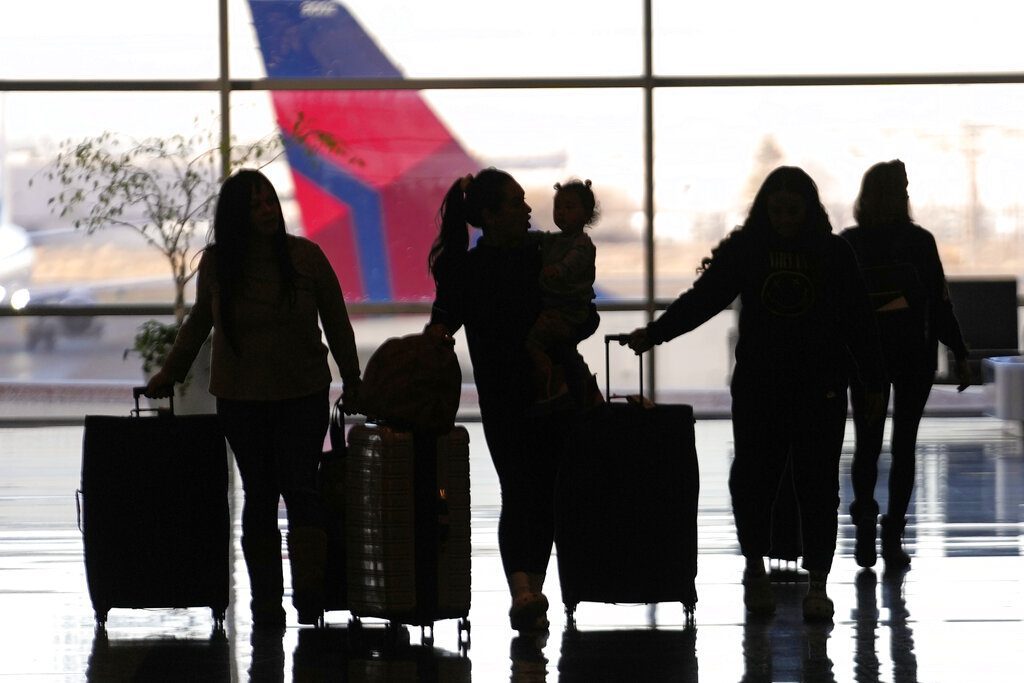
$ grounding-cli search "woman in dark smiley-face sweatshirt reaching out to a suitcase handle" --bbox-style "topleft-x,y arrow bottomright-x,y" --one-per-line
629,167 -> 882,620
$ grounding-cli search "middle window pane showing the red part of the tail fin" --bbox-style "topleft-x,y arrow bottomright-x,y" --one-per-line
232,89 -> 643,302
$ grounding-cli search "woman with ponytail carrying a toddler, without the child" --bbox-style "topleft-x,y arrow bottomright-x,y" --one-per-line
427,169 -> 596,631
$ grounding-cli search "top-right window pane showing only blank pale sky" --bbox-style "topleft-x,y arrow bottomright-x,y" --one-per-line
653,0 -> 1024,76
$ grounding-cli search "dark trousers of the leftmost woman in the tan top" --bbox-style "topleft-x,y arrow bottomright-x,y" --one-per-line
217,388 -> 330,540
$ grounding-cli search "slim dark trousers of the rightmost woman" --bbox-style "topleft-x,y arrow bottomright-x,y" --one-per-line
850,373 -> 934,519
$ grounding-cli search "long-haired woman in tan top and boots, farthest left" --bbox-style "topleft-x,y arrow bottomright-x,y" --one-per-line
145,169 -> 359,629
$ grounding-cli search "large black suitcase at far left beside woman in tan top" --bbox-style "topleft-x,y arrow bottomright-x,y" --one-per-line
81,387 -> 230,628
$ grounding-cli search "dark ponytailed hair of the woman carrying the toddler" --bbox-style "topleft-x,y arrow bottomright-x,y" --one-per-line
427,168 -> 514,283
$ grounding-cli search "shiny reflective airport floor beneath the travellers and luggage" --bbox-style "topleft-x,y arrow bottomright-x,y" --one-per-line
0,418 -> 1024,683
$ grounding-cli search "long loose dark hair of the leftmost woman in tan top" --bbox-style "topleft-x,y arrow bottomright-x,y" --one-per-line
212,169 -> 296,352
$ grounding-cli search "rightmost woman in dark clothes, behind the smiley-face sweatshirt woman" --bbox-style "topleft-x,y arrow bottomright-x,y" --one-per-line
842,160 -> 971,569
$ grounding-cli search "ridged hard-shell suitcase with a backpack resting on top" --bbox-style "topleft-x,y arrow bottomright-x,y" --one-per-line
345,423 -> 471,646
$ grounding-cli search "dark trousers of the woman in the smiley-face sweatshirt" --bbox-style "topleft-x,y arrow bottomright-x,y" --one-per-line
729,386 -> 847,571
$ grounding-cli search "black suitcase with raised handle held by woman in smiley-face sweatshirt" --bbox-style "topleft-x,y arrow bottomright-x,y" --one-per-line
555,335 -> 699,624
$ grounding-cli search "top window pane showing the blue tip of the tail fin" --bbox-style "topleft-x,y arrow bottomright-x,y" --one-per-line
231,0 -> 643,78
